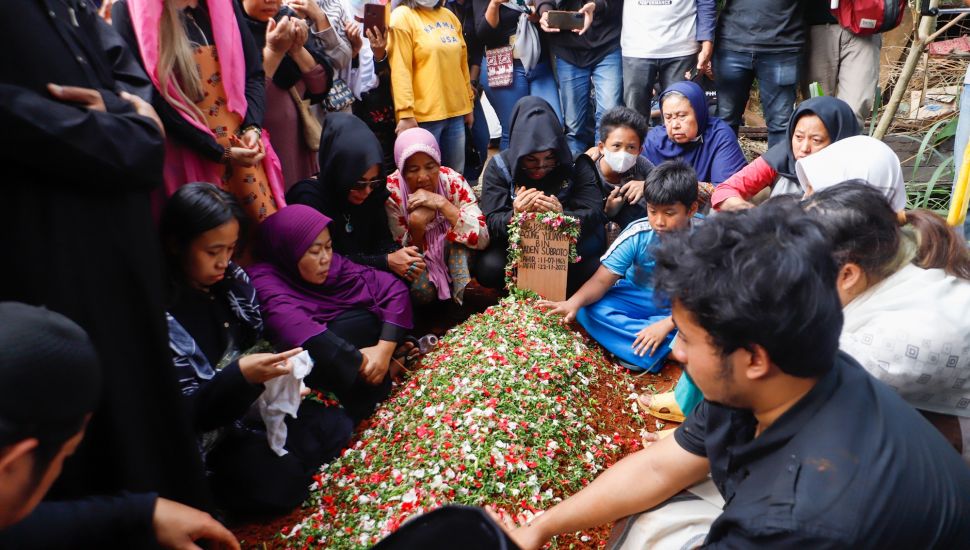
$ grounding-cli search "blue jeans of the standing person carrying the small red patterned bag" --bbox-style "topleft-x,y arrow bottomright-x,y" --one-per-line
481,59 -> 562,151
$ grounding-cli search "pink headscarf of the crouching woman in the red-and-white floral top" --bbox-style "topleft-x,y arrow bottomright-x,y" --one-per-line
394,128 -> 451,300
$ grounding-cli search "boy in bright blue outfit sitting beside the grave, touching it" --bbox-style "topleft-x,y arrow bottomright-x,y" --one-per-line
539,161 -> 702,372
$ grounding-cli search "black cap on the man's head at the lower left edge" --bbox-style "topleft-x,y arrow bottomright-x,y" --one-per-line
0,302 -> 101,447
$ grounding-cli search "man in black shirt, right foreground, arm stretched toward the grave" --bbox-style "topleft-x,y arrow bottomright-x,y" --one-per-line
492,202 -> 970,549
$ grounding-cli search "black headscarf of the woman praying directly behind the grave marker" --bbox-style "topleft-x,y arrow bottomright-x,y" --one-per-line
502,96 -> 573,194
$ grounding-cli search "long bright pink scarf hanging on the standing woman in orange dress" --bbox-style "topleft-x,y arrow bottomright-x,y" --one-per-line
128,0 -> 286,208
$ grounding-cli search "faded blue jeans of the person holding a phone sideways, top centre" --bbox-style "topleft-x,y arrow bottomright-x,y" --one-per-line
556,48 -> 623,157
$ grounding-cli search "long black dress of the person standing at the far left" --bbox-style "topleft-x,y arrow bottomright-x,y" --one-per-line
0,0 -> 210,508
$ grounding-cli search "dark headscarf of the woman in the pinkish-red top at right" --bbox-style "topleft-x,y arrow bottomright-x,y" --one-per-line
761,96 -> 859,181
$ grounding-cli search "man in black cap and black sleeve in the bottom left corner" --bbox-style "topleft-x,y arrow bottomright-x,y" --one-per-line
0,302 -> 239,550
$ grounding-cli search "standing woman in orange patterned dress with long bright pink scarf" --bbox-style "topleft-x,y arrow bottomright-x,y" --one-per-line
112,0 -> 290,221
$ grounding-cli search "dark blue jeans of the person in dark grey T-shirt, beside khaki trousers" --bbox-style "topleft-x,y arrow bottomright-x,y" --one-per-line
714,49 -> 801,147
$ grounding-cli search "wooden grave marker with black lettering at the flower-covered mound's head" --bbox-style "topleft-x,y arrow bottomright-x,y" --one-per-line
516,220 -> 569,301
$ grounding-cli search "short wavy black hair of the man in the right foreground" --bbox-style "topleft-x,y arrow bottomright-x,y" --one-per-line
654,201 -> 842,377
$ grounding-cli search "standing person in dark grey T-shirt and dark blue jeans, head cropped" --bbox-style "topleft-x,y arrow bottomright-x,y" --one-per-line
714,0 -> 800,147
